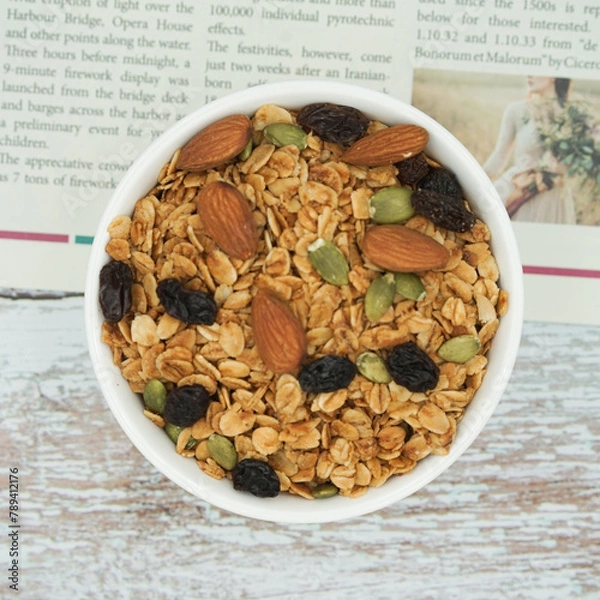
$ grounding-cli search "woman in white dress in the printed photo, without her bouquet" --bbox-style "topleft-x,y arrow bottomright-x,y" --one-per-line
484,76 -> 576,224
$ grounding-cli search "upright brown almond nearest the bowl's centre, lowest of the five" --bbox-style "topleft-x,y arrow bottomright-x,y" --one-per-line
251,290 -> 306,373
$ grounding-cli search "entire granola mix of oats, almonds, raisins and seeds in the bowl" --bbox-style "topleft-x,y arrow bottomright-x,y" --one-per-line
99,103 -> 508,499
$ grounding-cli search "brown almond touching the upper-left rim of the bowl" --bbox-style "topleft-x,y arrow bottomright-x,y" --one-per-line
177,115 -> 252,171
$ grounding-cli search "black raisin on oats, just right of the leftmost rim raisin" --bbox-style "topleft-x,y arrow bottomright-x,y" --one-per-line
156,279 -> 217,325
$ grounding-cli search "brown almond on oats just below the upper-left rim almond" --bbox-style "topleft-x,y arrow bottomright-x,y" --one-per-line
196,181 -> 258,260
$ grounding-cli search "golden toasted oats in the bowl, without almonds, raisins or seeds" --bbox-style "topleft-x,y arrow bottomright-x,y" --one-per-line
102,105 -> 508,499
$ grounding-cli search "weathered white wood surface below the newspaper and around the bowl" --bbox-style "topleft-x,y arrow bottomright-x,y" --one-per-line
0,297 -> 600,600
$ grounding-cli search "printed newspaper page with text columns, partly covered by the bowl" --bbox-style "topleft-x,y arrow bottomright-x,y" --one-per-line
0,0 -> 600,324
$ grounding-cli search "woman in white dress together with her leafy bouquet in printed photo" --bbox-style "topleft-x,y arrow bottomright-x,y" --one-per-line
484,76 -> 600,225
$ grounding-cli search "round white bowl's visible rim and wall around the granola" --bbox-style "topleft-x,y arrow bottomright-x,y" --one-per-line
85,81 -> 523,523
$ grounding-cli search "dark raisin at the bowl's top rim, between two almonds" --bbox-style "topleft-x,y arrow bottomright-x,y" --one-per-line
297,102 -> 369,144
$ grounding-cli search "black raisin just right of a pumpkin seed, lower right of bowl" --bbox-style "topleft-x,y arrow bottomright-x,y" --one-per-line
386,342 -> 440,392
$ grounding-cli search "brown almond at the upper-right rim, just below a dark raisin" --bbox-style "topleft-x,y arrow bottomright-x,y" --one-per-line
340,125 -> 429,167
